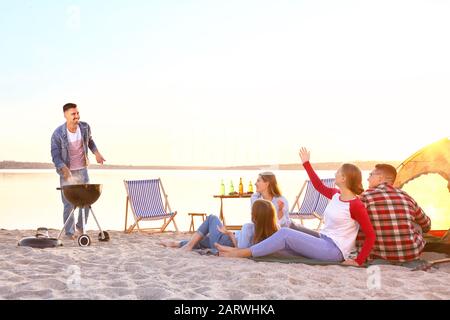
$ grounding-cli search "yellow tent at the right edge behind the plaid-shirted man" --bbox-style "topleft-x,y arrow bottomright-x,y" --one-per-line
394,137 -> 450,238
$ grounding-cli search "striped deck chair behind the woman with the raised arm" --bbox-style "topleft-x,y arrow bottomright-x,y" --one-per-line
289,178 -> 336,230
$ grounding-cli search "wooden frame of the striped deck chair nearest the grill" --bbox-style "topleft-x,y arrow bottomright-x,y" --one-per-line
124,178 -> 179,233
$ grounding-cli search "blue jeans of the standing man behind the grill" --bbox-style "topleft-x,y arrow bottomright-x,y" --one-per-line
60,168 -> 89,236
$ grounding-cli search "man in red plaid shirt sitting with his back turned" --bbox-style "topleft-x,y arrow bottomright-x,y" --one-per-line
358,164 -> 431,262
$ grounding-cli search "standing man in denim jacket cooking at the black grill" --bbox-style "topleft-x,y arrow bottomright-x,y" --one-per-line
51,103 -> 105,239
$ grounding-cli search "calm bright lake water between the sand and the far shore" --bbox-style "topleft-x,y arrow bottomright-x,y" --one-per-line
0,170 -> 450,231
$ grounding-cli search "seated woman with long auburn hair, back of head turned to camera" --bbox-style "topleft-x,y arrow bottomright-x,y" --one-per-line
160,200 -> 283,252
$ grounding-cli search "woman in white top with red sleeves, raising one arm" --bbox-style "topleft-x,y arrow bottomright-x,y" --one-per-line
216,148 -> 375,266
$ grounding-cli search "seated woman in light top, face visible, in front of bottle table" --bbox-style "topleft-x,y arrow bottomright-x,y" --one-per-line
250,171 -> 291,227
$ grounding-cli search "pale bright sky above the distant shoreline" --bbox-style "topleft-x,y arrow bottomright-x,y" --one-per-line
0,0 -> 450,165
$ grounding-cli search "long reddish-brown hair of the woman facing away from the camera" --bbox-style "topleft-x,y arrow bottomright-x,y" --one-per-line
252,199 -> 278,244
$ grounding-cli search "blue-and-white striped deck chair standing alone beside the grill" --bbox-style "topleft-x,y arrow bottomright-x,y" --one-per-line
124,178 -> 178,233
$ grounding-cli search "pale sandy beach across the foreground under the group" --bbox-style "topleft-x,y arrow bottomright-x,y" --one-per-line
0,230 -> 450,300
